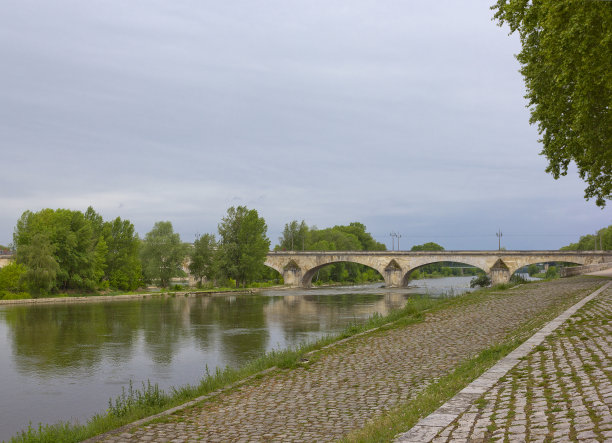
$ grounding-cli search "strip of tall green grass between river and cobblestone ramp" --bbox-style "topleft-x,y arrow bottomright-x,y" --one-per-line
10,297 -> 452,443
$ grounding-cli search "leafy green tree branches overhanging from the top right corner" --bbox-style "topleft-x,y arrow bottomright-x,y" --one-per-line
492,0 -> 612,208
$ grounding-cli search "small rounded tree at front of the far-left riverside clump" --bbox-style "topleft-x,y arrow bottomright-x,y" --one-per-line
17,232 -> 60,296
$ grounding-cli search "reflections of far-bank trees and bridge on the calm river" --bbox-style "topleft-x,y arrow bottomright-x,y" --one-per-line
3,294 -> 412,376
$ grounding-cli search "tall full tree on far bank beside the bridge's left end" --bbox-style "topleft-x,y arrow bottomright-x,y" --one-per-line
218,206 -> 270,286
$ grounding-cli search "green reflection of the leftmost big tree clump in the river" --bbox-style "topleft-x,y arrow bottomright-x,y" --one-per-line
5,303 -> 140,375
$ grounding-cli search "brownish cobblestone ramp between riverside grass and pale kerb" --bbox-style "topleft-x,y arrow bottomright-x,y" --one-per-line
99,277 -> 609,442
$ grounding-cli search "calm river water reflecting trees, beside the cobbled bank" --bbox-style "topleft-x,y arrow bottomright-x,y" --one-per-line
0,277 -> 471,439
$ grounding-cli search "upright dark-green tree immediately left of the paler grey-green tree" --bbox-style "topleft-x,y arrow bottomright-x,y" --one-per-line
102,217 -> 142,291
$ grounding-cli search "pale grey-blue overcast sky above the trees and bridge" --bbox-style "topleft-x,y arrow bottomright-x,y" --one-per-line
0,0 -> 612,249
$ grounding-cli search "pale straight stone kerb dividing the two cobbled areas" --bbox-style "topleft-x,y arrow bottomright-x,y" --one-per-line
394,282 -> 612,443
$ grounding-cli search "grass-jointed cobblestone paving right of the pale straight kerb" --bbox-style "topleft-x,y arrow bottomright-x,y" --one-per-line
433,288 -> 612,443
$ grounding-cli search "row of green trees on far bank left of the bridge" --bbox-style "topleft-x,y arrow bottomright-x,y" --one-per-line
0,206 -> 272,298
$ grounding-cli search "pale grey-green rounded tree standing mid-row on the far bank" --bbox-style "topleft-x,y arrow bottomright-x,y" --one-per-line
141,221 -> 187,288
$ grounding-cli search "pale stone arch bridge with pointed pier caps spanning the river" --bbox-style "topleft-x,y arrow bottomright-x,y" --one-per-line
265,251 -> 612,287
